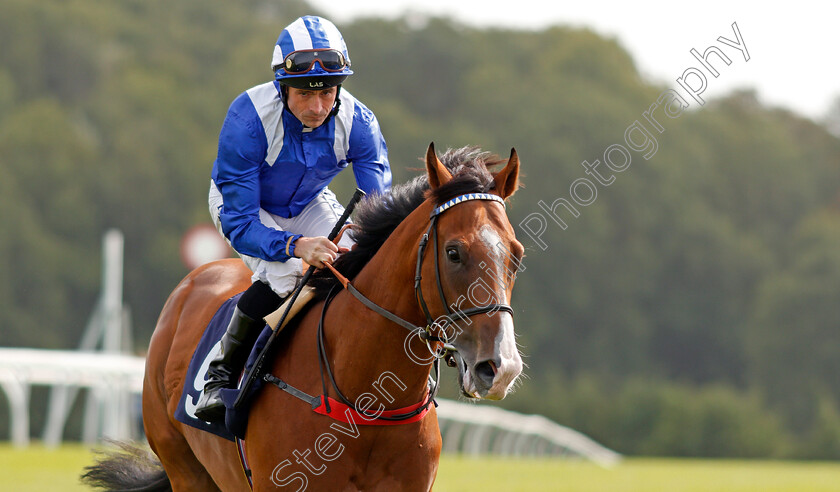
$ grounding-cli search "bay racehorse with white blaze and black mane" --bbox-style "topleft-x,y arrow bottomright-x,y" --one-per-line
82,145 -> 523,492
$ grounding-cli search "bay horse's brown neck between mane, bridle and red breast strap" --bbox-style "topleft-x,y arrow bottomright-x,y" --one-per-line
327,206 -> 431,408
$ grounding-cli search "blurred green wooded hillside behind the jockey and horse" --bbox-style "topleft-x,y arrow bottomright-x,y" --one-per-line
0,0 -> 840,458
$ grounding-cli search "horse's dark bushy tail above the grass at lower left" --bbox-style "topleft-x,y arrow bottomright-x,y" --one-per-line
81,442 -> 172,492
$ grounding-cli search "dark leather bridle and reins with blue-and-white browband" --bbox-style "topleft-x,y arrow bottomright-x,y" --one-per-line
318,193 -> 513,420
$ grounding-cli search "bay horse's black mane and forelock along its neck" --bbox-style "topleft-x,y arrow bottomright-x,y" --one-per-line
309,147 -> 505,299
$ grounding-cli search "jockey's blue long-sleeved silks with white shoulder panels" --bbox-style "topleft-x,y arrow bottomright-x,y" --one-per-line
212,82 -> 391,261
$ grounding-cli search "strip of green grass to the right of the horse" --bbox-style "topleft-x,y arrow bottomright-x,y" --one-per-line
435,456 -> 840,492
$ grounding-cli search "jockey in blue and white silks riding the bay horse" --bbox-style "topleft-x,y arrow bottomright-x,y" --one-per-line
195,16 -> 391,421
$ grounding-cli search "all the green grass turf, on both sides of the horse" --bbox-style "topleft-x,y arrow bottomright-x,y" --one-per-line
0,443 -> 840,492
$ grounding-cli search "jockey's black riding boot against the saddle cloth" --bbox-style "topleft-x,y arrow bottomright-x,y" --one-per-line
195,307 -> 265,422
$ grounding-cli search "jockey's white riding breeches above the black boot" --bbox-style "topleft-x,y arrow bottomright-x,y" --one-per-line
208,180 -> 353,297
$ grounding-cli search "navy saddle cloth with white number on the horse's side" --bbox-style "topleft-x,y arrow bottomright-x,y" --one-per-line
175,293 -> 271,441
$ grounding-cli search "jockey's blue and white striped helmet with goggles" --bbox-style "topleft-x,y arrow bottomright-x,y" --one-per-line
271,15 -> 353,89
